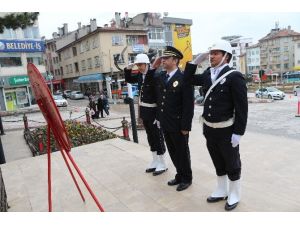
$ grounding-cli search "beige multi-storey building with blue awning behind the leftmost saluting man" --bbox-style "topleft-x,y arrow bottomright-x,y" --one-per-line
56,20 -> 149,98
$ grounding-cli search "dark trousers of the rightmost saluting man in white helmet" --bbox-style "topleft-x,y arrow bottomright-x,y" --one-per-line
203,124 -> 242,181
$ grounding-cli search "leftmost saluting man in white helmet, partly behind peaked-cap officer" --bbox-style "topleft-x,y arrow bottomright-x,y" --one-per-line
124,54 -> 168,176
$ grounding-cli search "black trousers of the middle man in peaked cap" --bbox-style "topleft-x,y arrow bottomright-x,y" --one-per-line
164,131 -> 193,183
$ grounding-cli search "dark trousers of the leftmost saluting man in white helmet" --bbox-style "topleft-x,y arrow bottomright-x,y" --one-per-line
143,120 -> 166,155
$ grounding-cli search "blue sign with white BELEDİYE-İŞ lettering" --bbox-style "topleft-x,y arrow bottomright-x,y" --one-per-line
0,40 -> 45,52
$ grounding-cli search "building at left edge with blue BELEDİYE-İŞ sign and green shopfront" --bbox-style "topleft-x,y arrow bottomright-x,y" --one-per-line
0,13 -> 46,111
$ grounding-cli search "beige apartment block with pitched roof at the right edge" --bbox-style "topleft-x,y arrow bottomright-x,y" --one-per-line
259,24 -> 300,75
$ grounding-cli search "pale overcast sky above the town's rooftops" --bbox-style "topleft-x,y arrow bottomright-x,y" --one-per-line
39,11 -> 300,54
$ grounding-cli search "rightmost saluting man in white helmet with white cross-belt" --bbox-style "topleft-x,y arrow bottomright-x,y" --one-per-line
186,40 -> 248,211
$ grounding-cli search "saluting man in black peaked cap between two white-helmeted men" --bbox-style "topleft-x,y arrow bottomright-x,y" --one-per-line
153,46 -> 194,191
